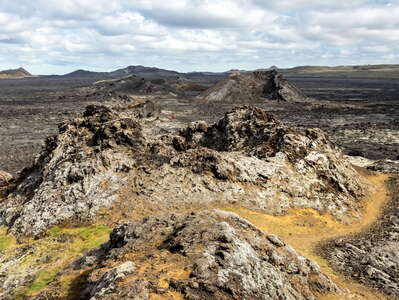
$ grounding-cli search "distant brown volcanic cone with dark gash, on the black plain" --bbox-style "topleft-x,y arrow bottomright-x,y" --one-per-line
197,70 -> 307,103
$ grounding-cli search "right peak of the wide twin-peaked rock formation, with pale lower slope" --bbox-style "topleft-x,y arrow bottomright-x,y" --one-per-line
172,106 -> 367,219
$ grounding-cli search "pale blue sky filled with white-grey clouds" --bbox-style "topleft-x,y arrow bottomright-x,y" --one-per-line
0,0 -> 399,74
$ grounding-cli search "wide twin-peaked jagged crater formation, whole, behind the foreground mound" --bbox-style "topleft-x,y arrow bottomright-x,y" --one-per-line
0,106 -> 367,236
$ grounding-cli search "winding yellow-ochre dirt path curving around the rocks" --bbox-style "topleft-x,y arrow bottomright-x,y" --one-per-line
221,174 -> 389,300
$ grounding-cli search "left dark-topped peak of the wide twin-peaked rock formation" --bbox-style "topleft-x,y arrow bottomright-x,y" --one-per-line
0,106 -> 145,235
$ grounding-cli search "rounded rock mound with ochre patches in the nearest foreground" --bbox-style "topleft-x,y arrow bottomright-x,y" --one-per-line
75,210 -> 340,300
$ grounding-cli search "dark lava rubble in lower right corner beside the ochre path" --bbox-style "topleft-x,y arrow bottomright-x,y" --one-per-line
324,177 -> 399,299
